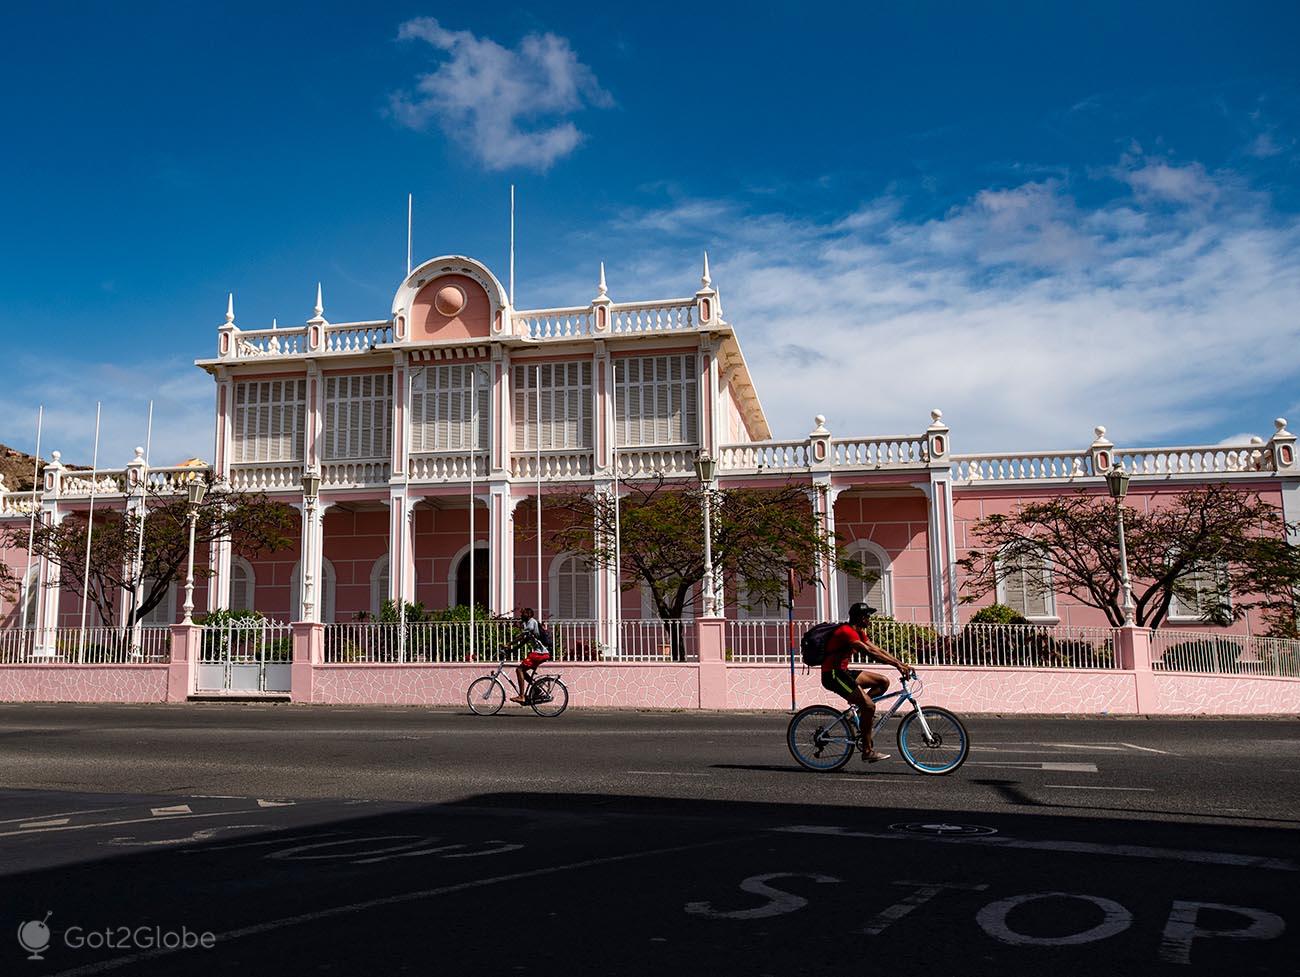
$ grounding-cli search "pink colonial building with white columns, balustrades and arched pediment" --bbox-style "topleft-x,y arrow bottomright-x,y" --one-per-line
0,255 -> 1300,711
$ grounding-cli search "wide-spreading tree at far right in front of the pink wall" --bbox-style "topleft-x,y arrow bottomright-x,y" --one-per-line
959,485 -> 1300,635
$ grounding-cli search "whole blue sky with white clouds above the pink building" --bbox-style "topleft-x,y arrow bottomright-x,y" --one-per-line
0,3 -> 1300,464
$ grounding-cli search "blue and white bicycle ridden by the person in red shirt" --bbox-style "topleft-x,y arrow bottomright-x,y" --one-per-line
785,672 -> 971,774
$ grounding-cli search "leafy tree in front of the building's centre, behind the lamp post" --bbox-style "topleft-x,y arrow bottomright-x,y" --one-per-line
538,478 -> 876,659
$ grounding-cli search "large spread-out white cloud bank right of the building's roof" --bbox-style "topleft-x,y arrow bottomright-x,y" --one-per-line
577,160 -> 1300,451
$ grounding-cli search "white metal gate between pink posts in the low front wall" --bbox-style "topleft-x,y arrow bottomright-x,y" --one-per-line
195,618 -> 294,695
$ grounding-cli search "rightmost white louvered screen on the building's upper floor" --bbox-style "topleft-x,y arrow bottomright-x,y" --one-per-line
615,353 -> 699,447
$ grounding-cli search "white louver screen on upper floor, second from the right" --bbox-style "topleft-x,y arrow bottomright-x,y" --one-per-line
514,362 -> 592,451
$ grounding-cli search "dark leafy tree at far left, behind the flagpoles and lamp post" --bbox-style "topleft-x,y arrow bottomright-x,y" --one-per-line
0,479 -> 298,629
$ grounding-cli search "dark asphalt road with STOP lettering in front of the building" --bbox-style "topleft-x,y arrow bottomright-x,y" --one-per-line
0,704 -> 1300,977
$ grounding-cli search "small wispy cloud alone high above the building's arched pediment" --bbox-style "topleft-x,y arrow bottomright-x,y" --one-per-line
390,17 -> 612,170
